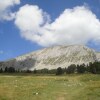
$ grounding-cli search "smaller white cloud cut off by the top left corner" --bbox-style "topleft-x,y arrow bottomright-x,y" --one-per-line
0,0 -> 20,20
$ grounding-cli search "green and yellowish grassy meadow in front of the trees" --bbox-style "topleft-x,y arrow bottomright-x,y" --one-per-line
0,74 -> 100,100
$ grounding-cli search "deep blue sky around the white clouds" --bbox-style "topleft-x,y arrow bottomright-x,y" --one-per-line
0,0 -> 100,61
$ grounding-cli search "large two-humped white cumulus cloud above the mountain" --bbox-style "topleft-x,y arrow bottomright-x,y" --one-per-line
15,5 -> 100,46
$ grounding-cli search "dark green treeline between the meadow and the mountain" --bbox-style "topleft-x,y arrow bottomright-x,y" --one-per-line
0,62 -> 100,75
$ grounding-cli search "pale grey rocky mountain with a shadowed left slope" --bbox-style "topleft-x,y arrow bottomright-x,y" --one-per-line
0,45 -> 100,70
